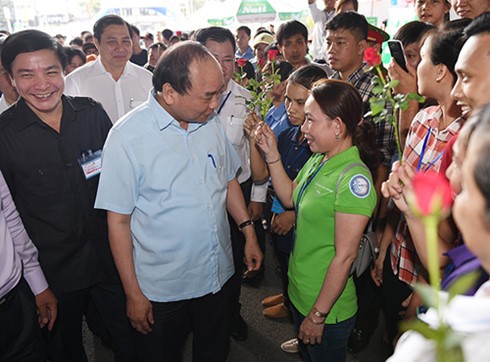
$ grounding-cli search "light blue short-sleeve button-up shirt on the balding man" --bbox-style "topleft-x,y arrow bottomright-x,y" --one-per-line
95,92 -> 240,302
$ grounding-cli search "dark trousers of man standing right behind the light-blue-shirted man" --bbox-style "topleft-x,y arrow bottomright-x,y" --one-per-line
228,178 -> 265,316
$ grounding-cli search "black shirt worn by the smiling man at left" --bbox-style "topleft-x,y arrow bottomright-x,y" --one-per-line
0,96 -> 115,292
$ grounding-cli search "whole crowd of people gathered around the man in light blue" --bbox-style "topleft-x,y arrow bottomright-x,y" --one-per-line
0,0 -> 490,362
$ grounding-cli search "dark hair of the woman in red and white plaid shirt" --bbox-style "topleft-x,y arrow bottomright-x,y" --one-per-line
429,19 -> 471,83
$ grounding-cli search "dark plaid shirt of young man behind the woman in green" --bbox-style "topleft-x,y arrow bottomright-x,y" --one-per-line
332,63 -> 396,166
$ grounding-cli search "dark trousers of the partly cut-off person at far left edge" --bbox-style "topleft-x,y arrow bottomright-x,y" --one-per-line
0,278 -> 47,362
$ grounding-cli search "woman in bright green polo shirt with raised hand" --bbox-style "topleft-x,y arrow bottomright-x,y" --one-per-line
256,79 -> 379,361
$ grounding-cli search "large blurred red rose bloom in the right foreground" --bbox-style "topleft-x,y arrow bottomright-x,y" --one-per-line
412,171 -> 453,216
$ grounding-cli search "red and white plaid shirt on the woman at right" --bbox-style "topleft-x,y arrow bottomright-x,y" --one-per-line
391,106 -> 465,285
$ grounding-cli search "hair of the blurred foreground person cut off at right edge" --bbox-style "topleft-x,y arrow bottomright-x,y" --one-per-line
465,103 -> 490,223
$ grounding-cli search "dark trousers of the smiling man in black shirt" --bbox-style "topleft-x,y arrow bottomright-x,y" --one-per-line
44,280 -> 136,362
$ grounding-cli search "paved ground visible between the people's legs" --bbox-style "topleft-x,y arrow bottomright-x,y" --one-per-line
84,238 -> 389,362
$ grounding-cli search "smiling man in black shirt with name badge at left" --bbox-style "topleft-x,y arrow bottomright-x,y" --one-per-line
0,30 -> 134,362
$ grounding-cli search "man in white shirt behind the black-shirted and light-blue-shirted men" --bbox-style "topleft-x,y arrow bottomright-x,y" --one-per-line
65,15 -> 152,123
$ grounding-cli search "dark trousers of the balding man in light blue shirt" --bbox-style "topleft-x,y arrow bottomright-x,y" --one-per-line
136,281 -> 231,362
